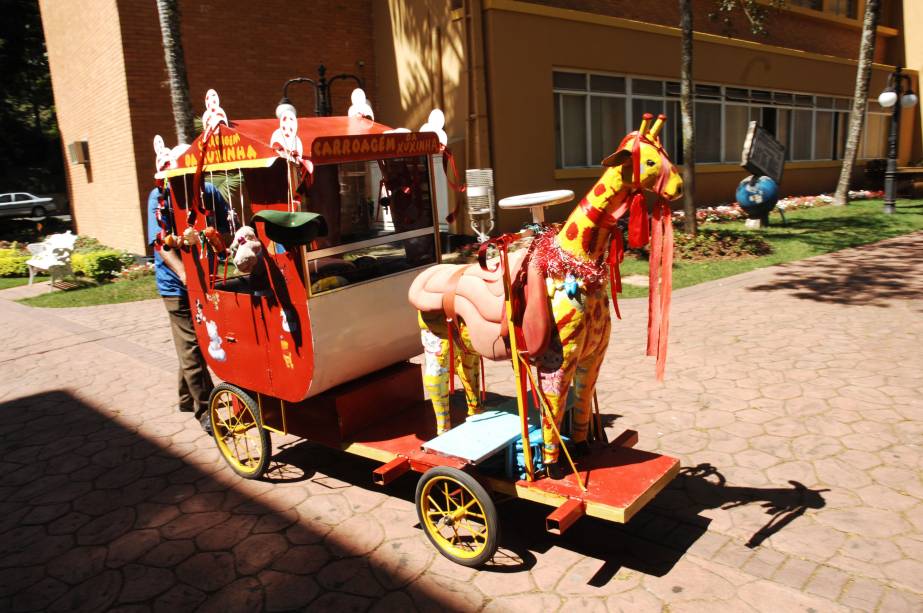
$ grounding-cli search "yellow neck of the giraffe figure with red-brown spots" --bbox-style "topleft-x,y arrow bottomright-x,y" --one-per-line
557,166 -> 630,262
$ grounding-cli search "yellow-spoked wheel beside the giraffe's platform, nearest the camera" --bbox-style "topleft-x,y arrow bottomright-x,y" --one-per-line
416,466 -> 500,566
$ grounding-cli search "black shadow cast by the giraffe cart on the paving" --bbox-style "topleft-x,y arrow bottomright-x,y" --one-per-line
273,428 -> 826,587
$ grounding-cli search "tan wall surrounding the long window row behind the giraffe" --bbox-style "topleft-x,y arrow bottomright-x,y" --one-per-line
485,3 -> 919,228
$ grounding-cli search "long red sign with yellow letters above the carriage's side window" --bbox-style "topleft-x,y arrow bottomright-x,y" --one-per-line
311,132 -> 439,164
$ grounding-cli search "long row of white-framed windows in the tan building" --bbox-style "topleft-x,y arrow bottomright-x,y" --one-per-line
553,71 -> 888,168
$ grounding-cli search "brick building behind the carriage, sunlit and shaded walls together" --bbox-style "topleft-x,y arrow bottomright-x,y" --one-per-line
41,0 -> 376,253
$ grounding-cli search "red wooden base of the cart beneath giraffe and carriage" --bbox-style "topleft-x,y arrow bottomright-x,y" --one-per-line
260,363 -> 679,523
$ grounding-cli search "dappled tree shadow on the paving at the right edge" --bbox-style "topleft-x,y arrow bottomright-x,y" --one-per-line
747,235 -> 923,308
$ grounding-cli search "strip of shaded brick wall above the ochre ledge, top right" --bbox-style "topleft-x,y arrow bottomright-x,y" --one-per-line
525,0 -> 889,62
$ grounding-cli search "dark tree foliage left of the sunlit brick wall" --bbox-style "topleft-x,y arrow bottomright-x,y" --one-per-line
0,0 -> 65,193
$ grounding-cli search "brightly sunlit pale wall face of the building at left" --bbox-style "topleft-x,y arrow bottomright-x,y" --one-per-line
39,0 -> 145,253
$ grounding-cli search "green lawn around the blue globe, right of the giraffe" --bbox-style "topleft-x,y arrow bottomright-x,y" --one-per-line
621,200 -> 923,298
